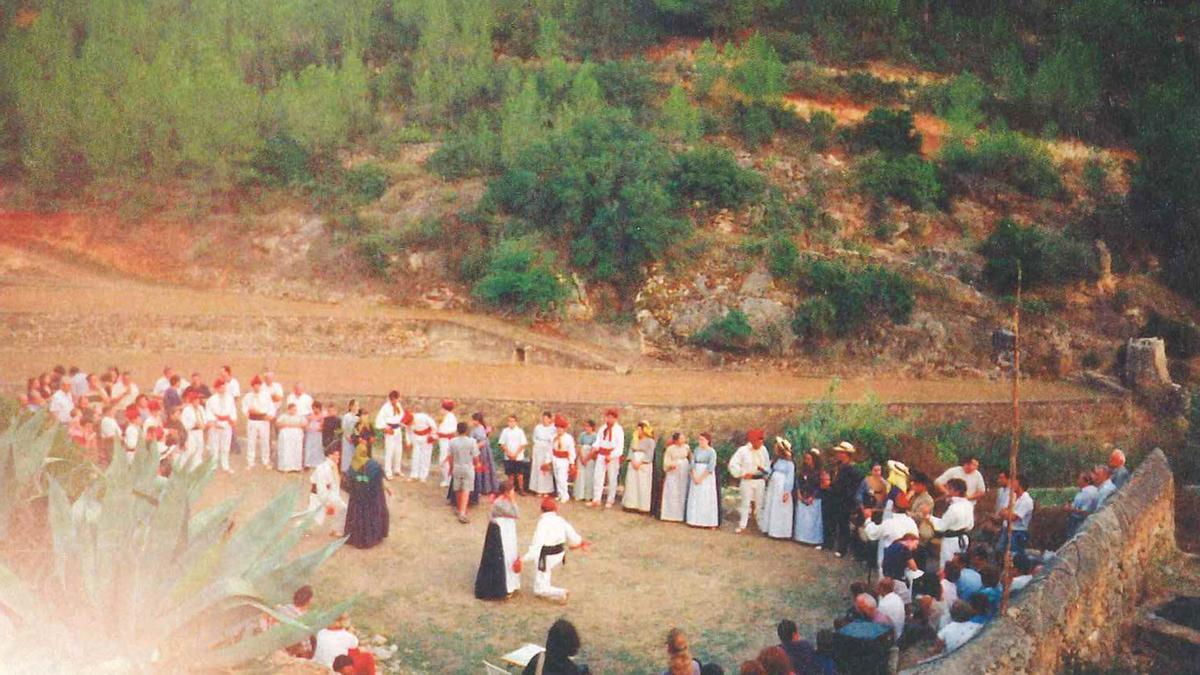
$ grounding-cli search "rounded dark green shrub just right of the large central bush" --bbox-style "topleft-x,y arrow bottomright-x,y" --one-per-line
671,145 -> 764,208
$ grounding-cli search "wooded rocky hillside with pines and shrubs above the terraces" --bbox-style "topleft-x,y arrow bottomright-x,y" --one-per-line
0,0 -> 1200,375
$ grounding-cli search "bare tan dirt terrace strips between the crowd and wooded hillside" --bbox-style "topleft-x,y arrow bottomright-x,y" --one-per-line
0,239 -> 1086,405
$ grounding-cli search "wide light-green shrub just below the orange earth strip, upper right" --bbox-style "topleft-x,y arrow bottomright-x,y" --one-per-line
941,131 -> 1062,198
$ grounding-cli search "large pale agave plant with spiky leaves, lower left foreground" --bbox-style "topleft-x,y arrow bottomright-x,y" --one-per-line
0,437 -> 353,673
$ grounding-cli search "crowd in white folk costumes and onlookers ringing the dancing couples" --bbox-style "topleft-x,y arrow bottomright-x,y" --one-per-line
22,366 -> 1129,673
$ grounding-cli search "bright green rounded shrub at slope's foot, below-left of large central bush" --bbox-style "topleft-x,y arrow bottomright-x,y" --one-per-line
472,237 -> 566,313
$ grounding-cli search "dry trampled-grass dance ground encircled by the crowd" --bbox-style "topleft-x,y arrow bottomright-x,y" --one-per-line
205,458 -> 860,673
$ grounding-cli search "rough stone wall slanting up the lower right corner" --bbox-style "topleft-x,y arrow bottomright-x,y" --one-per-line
906,449 -> 1176,675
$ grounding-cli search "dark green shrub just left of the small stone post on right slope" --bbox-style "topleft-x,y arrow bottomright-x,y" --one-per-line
979,219 -> 1097,292
